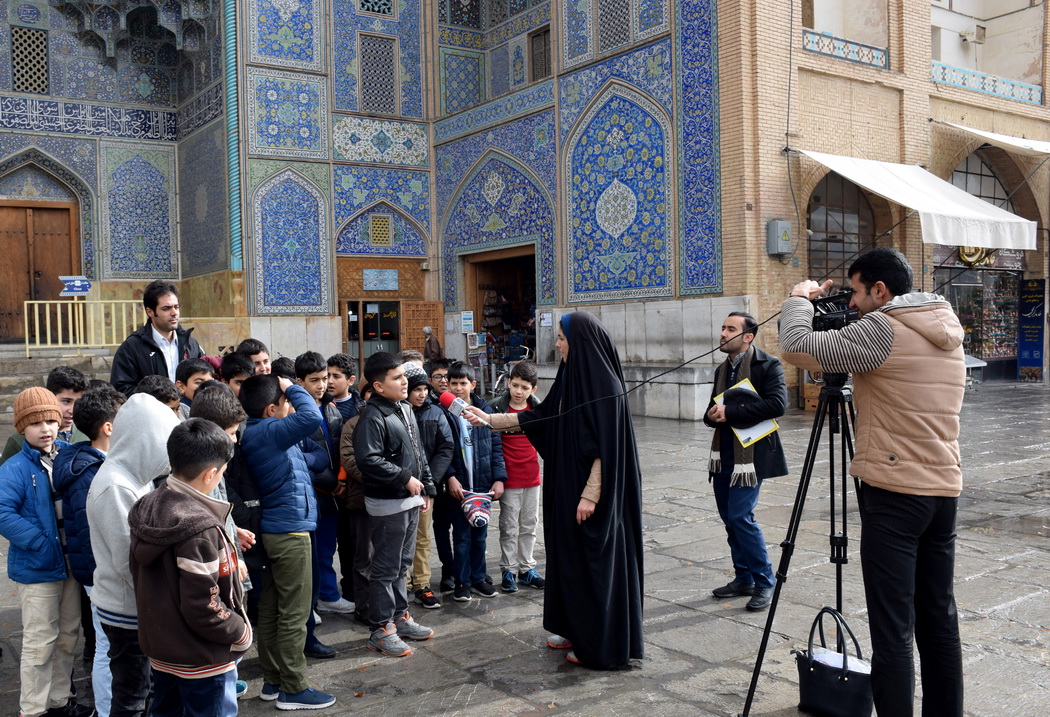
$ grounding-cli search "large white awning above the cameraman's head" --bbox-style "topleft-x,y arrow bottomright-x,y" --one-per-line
799,149 -> 1035,250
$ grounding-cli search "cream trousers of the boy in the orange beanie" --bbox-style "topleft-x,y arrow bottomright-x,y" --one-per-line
18,577 -> 80,715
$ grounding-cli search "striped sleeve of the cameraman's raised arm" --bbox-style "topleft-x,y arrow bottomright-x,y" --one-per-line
780,297 -> 894,374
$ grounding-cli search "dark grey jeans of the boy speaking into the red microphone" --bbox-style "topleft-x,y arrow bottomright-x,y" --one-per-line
369,507 -> 419,630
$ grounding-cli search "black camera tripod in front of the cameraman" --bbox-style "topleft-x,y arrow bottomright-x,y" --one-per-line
740,373 -> 859,717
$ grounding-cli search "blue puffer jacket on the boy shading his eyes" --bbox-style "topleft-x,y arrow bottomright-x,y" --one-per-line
240,385 -> 321,533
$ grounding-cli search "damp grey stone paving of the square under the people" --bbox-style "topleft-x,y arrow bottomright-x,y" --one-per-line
0,384 -> 1050,717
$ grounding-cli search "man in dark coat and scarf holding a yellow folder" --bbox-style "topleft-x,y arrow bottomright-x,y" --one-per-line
704,312 -> 788,611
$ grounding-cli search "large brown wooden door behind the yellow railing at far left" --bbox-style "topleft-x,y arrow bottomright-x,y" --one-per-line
0,202 -> 80,340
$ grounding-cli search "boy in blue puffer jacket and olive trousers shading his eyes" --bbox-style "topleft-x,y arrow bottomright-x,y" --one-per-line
237,374 -> 335,710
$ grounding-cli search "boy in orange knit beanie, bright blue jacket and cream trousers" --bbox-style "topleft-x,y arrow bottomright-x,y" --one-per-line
0,386 -> 92,716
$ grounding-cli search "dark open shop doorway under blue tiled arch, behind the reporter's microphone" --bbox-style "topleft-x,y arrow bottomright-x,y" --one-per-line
463,245 -> 536,386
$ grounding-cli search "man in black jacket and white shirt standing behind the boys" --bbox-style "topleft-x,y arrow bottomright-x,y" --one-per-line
109,279 -> 204,396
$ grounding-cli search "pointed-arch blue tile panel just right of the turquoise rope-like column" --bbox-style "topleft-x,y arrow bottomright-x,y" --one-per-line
252,169 -> 332,314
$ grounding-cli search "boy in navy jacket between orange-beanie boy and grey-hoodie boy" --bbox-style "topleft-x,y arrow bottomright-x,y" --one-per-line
51,385 -> 127,715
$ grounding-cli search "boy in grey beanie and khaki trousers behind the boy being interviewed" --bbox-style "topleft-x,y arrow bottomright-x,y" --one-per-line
404,363 -> 455,610
